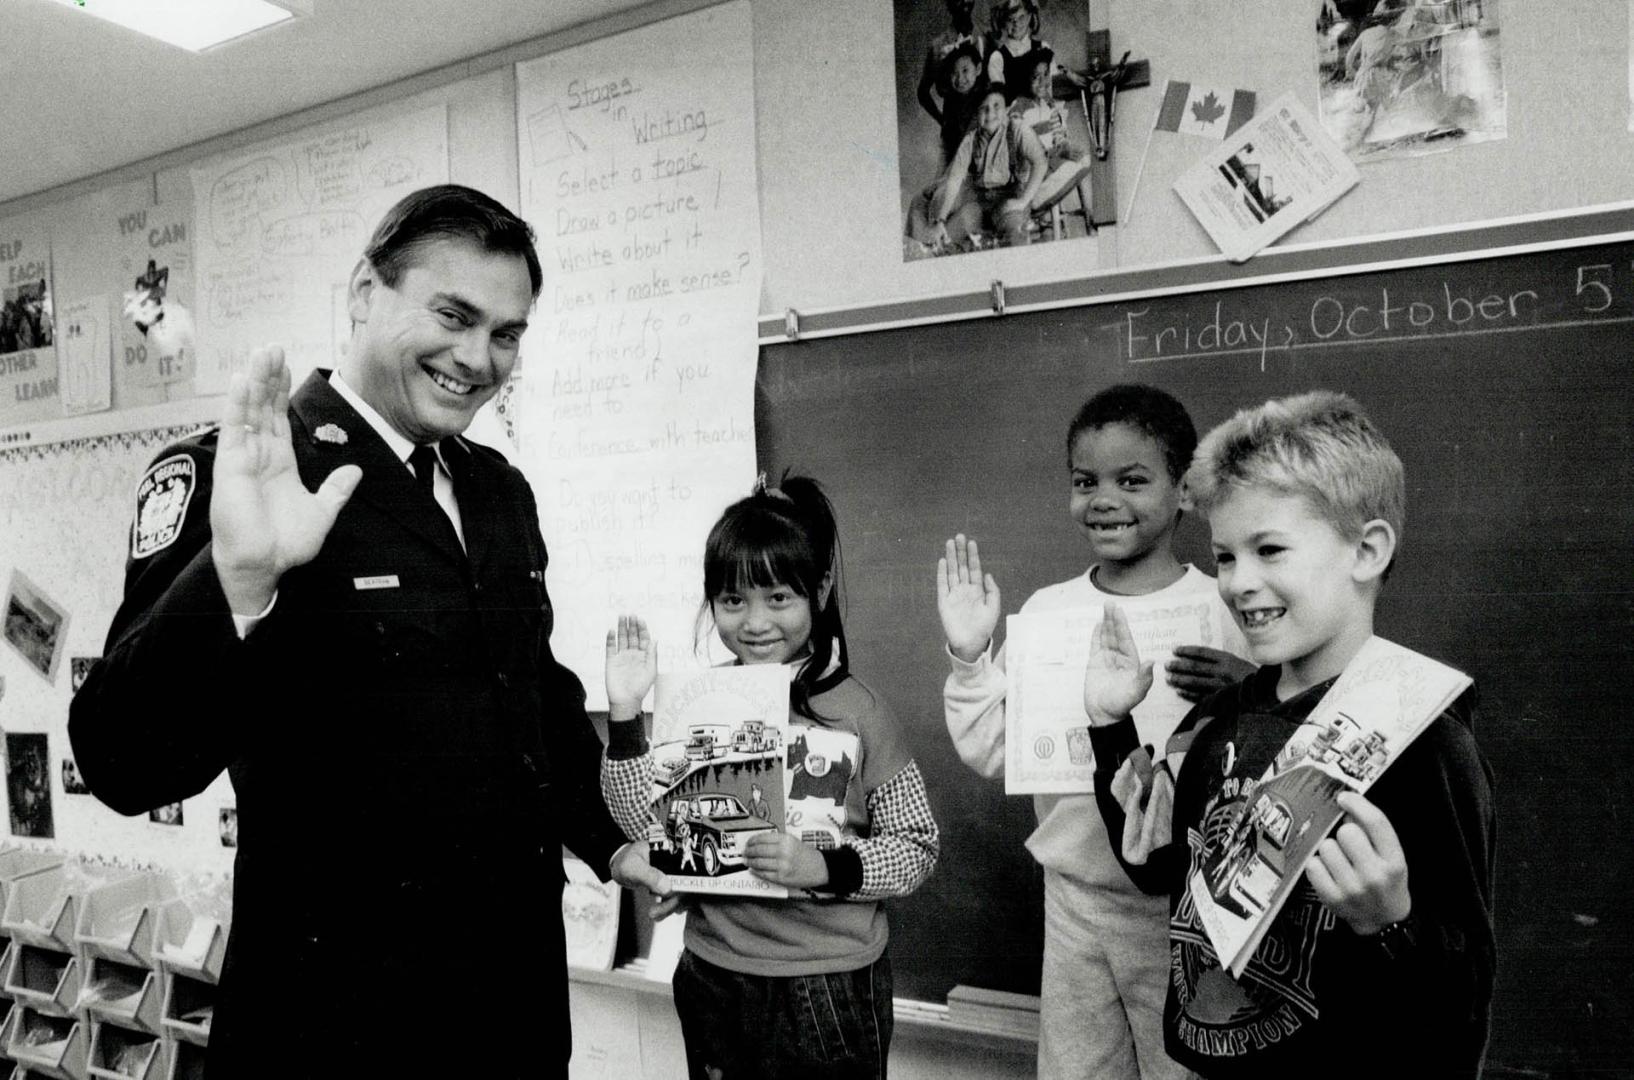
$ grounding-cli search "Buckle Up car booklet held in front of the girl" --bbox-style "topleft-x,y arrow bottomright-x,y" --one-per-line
647,663 -> 789,897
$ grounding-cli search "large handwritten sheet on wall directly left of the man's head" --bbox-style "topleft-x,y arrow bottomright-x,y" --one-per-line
193,106 -> 448,394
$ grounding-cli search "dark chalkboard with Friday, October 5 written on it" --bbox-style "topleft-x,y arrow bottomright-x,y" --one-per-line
757,242 -> 1634,1075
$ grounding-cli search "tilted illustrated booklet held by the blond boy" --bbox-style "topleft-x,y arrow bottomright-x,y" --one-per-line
1190,637 -> 1471,975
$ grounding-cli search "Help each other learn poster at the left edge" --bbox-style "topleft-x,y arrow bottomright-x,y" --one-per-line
0,217 -> 62,426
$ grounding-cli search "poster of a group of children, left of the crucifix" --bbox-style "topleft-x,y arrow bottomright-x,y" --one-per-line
894,0 -> 1092,260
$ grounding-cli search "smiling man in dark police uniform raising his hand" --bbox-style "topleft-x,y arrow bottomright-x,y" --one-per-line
69,185 -> 667,1077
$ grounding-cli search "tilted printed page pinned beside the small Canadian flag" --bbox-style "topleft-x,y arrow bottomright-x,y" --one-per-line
1175,93 -> 1359,263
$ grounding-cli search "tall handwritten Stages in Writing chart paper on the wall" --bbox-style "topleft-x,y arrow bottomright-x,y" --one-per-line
516,2 -> 761,707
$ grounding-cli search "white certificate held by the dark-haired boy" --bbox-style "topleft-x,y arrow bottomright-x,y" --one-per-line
1005,593 -> 1227,794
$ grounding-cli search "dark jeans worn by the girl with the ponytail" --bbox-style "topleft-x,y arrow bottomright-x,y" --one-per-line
673,949 -> 894,1080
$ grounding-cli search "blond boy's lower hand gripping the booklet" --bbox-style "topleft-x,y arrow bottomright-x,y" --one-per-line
1306,791 -> 1413,938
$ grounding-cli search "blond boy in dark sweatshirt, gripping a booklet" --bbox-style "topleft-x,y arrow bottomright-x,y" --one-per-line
1085,392 -> 1493,1080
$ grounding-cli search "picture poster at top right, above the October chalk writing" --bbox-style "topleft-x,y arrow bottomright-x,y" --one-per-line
1315,0 -> 1508,162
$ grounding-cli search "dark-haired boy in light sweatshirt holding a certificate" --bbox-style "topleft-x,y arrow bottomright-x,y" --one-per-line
938,384 -> 1252,1080
